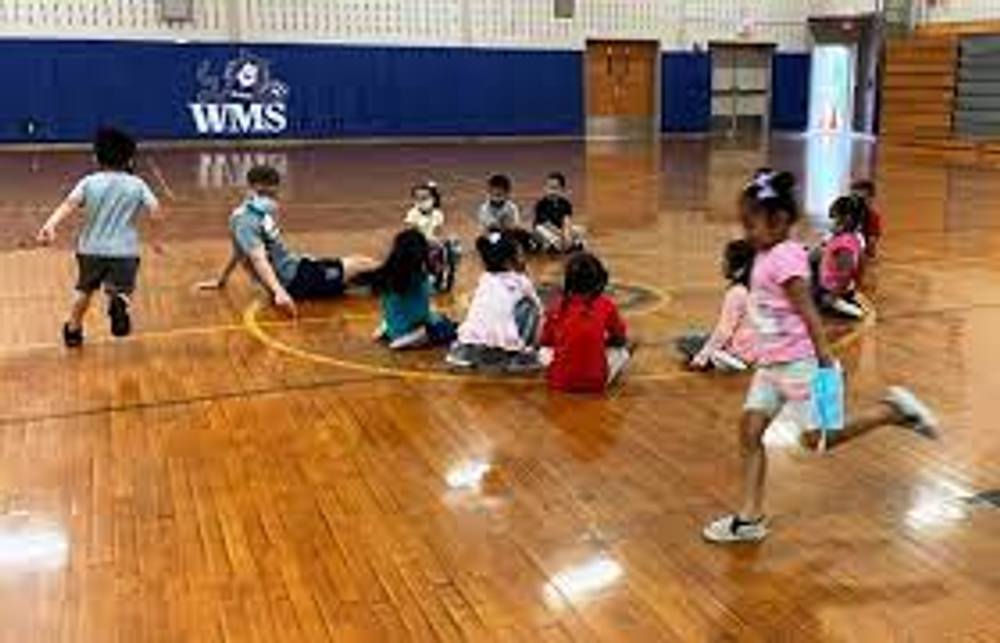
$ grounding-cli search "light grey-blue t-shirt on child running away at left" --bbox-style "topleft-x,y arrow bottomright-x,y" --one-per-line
69,172 -> 159,257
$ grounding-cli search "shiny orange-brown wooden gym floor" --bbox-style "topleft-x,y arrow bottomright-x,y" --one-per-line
0,139 -> 1000,643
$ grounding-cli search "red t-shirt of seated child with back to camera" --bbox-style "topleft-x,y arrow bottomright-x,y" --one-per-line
542,295 -> 626,393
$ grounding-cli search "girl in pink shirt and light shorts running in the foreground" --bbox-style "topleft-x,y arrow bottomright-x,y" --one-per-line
703,173 -> 937,543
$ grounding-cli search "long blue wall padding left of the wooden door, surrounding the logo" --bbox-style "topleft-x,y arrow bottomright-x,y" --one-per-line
0,40 -> 584,141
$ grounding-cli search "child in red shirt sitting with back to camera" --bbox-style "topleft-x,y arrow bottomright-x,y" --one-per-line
542,252 -> 631,393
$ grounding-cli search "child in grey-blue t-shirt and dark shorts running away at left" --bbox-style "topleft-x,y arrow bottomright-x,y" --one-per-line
38,129 -> 162,348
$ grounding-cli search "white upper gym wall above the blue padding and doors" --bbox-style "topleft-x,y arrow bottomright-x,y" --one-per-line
0,0 -> 820,49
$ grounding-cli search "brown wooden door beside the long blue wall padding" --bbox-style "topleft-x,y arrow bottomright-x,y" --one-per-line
587,40 -> 659,118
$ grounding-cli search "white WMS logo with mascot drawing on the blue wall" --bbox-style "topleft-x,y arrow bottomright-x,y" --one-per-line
188,51 -> 288,136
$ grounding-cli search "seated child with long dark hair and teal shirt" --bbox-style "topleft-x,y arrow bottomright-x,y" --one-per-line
364,229 -> 455,350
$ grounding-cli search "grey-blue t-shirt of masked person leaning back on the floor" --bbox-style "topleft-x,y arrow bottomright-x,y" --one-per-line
229,194 -> 302,288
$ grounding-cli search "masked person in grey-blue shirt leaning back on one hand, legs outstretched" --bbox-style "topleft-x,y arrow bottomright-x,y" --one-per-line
197,165 -> 377,315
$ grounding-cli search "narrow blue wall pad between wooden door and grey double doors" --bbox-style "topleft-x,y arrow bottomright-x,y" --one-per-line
661,52 -> 712,132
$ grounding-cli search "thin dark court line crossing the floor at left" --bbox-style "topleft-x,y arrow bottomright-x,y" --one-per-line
0,375 -> 399,427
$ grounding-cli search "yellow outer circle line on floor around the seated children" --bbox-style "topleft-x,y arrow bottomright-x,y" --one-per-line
236,296 -> 876,385
